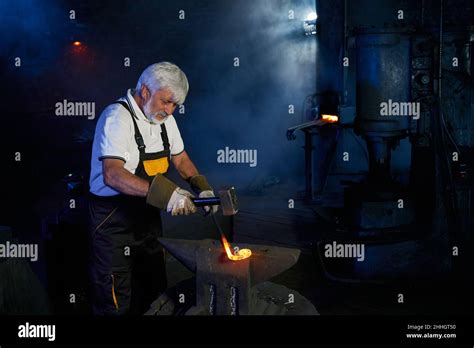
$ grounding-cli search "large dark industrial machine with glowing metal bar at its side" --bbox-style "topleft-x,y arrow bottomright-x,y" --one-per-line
287,0 -> 474,281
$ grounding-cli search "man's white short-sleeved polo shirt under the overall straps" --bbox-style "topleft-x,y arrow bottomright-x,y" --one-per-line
89,89 -> 184,196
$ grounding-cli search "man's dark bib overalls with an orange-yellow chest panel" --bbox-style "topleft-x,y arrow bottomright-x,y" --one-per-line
89,101 -> 170,315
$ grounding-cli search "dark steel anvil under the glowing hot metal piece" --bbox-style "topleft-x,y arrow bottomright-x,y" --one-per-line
159,238 -> 301,315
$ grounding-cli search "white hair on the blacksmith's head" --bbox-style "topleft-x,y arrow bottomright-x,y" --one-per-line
136,62 -> 189,104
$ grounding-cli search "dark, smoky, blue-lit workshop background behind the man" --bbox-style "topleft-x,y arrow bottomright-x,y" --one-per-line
0,0 -> 474,314
